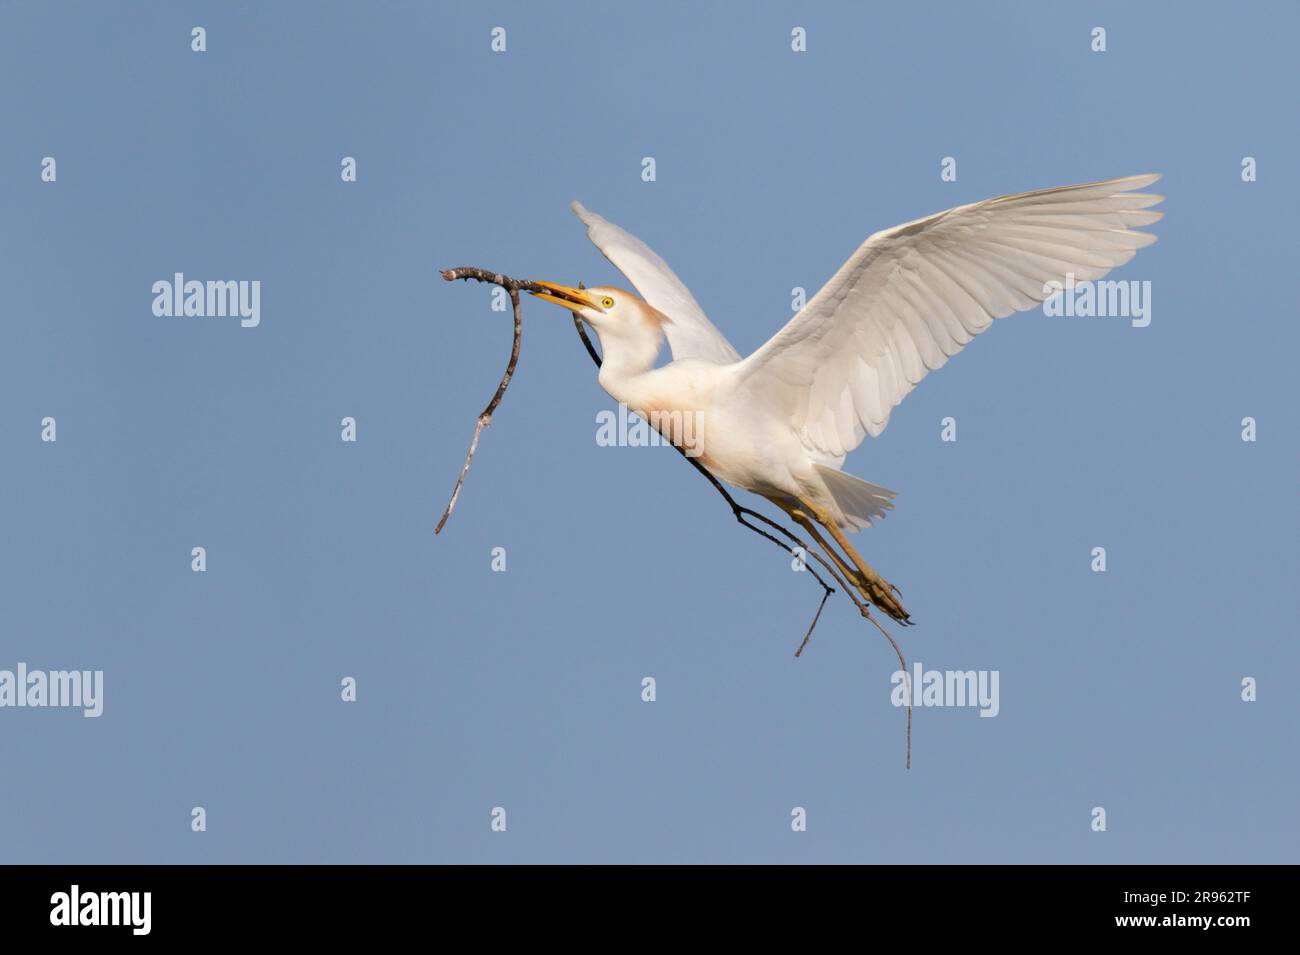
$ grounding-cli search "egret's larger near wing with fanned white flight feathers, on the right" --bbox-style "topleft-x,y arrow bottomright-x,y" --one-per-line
737,174 -> 1164,459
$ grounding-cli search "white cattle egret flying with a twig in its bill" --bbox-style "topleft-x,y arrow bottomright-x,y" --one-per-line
533,174 -> 1164,622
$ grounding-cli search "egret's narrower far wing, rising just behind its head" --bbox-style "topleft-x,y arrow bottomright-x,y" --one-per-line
571,200 -> 740,364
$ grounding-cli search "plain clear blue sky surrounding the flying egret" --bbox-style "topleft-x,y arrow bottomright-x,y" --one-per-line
0,3 -> 1300,863
